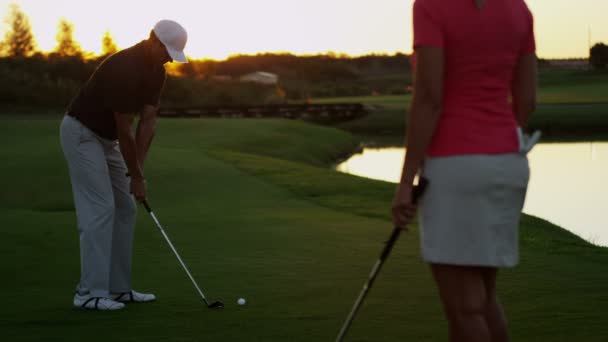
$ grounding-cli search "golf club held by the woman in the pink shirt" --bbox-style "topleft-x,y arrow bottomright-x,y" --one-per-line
336,177 -> 428,342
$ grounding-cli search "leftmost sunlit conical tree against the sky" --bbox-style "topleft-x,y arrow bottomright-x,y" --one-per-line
0,4 -> 36,57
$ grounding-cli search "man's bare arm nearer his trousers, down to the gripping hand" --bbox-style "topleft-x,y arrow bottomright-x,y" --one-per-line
114,113 -> 146,200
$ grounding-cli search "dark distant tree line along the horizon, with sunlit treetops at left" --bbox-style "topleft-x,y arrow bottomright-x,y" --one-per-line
0,4 -> 608,111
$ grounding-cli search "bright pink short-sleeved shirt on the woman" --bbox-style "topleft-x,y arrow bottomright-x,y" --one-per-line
414,0 -> 535,157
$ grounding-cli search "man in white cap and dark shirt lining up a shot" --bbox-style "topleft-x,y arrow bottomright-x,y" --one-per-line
61,20 -> 187,310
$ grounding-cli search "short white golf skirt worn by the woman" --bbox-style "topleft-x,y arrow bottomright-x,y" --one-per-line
420,153 -> 530,267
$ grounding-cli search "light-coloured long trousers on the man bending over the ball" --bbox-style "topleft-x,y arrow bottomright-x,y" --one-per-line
60,115 -> 137,297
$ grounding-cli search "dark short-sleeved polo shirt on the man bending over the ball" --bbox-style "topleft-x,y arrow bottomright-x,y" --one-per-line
67,42 -> 166,140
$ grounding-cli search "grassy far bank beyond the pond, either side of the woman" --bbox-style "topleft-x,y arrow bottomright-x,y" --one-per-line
315,70 -> 608,144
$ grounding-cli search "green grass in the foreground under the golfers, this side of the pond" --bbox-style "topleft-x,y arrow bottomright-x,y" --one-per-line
0,120 -> 608,341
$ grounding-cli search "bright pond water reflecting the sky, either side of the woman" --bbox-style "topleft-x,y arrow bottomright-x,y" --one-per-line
337,143 -> 608,246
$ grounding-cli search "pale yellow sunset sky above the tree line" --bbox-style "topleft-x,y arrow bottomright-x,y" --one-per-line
0,0 -> 608,59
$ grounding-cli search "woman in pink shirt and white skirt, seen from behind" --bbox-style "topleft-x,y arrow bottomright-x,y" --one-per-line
393,0 -> 536,342
